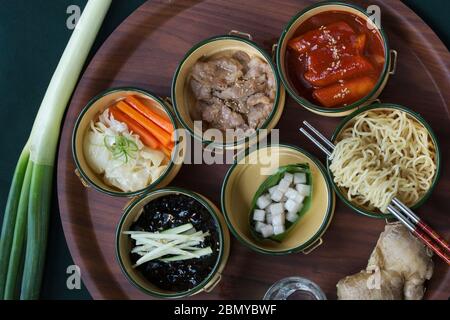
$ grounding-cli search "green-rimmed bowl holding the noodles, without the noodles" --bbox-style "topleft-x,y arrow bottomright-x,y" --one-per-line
327,103 -> 441,219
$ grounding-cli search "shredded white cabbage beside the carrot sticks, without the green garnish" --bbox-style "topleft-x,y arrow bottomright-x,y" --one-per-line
83,109 -> 167,192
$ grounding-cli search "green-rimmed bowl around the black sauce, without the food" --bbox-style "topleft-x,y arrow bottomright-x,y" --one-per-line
116,188 -> 230,298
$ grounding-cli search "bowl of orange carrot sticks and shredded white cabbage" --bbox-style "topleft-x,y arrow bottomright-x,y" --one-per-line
72,88 -> 185,196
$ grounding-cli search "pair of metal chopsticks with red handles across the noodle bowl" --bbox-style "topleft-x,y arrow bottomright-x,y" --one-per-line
300,121 -> 450,265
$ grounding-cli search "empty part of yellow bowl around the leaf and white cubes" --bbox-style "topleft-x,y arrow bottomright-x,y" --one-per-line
221,144 -> 335,255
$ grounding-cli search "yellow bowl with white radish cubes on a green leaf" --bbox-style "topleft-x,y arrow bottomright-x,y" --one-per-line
221,145 -> 335,255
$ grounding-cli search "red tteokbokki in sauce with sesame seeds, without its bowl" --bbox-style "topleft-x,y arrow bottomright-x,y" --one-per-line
286,11 -> 385,108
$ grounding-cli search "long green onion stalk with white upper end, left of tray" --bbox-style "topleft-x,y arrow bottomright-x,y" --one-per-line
0,0 -> 112,300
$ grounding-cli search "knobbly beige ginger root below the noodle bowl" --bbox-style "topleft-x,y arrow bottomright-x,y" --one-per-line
337,223 -> 433,300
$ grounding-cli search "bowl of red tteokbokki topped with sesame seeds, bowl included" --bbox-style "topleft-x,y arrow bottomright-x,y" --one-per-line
276,2 -> 397,117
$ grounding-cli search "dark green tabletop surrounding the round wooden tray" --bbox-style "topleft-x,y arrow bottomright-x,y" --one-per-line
0,0 -> 450,299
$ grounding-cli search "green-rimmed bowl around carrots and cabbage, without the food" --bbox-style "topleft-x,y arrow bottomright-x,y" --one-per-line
72,87 -> 186,197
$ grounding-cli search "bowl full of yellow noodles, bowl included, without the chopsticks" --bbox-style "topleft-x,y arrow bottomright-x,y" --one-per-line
327,103 -> 440,219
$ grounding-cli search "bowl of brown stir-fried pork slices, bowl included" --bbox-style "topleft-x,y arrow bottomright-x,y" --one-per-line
172,35 -> 285,149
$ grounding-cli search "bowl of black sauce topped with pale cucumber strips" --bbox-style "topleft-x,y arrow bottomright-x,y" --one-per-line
116,188 -> 230,298
